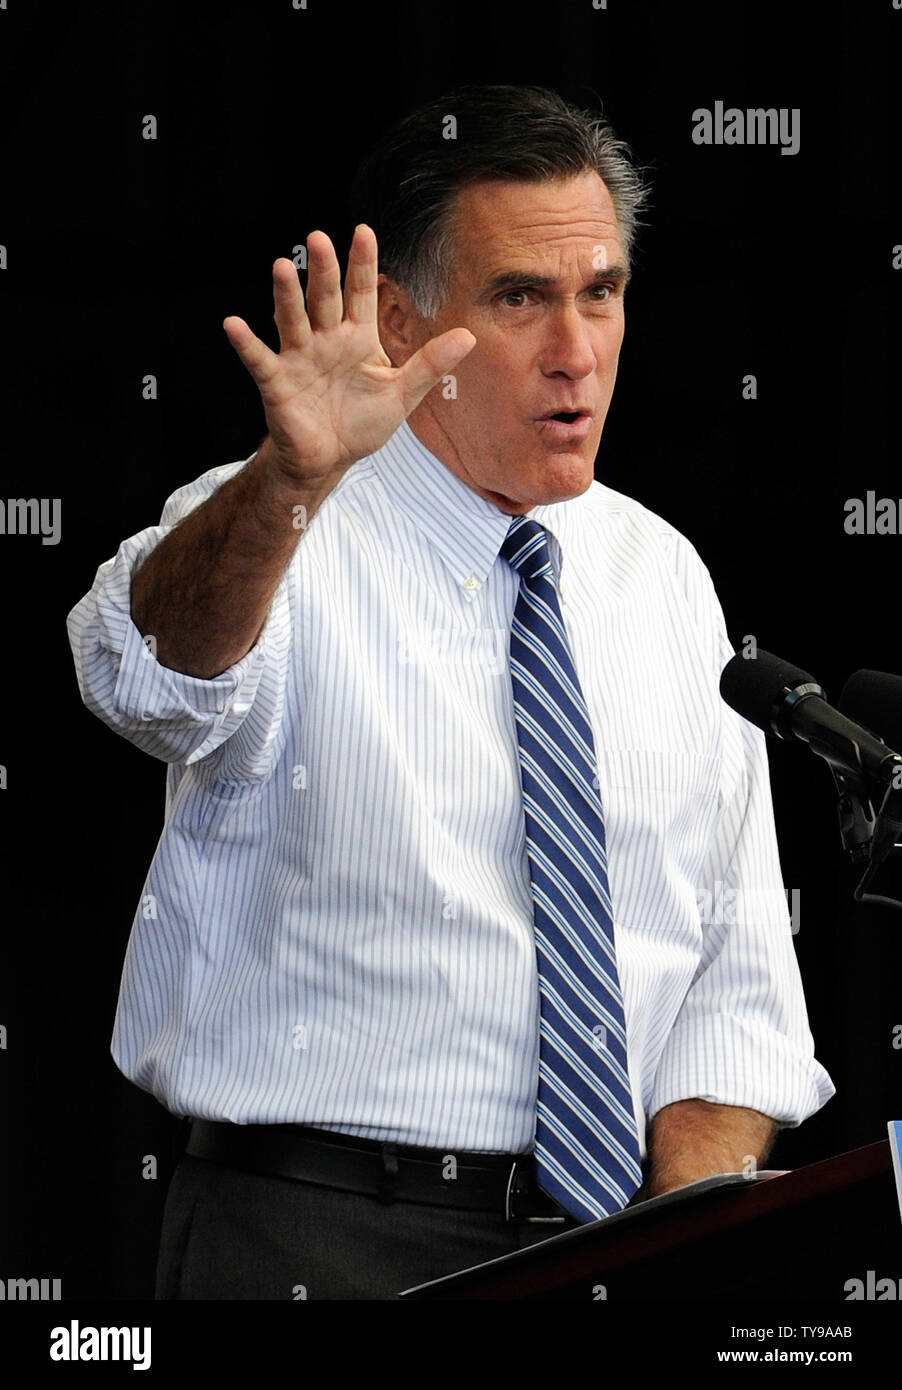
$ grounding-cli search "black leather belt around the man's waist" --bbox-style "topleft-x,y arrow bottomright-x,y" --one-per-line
185,1119 -> 571,1225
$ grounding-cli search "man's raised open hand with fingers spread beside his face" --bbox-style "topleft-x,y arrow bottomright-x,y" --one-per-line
222,222 -> 475,493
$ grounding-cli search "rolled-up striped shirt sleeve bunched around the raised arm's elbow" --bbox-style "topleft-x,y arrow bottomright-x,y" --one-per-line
67,456 -> 290,766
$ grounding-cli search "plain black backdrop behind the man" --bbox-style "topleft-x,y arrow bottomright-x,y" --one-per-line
0,0 -> 902,1298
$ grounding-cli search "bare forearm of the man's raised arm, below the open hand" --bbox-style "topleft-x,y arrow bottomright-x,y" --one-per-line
131,430 -> 328,680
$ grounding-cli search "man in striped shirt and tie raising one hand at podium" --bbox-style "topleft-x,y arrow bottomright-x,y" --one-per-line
69,86 -> 833,1298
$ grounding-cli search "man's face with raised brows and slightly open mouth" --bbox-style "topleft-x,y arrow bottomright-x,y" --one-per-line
379,172 -> 627,516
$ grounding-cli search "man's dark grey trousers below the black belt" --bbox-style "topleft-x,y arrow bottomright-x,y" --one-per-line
156,1154 -> 578,1300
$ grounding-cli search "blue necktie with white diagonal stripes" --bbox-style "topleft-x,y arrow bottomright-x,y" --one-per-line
500,516 -> 642,1222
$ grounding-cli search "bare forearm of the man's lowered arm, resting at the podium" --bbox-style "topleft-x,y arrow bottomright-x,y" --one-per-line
642,1099 -> 780,1197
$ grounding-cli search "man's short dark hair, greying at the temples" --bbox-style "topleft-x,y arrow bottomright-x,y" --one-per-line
350,83 -> 648,318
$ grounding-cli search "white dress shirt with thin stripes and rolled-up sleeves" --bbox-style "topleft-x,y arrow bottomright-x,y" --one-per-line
68,423 -> 834,1155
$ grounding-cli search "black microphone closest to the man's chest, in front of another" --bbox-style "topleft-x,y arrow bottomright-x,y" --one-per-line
720,648 -> 902,787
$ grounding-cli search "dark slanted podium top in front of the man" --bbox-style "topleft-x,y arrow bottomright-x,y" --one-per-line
400,1140 -> 902,1302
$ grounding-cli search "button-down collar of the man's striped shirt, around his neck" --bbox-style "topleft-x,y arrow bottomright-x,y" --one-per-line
370,420 -> 580,587
